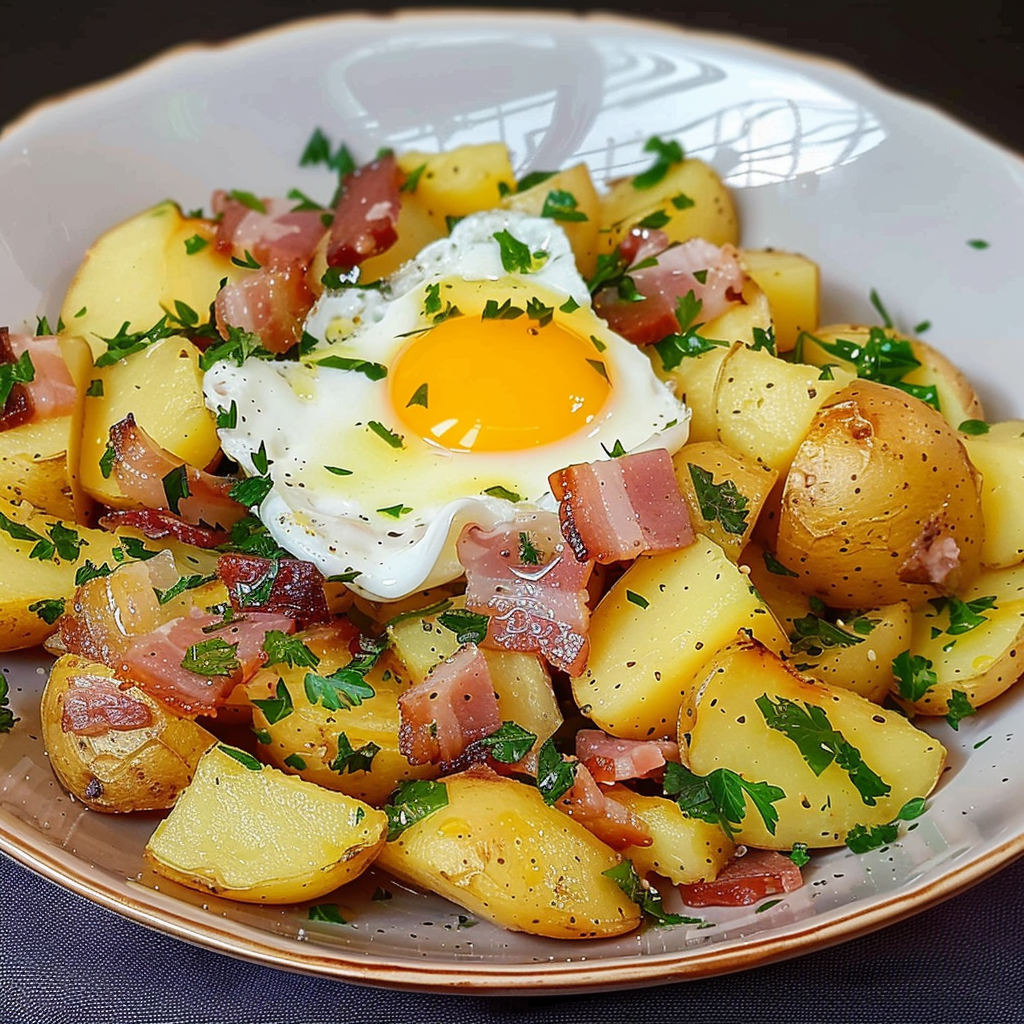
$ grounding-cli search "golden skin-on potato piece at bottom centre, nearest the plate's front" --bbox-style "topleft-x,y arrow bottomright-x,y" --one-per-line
377,768 -> 640,939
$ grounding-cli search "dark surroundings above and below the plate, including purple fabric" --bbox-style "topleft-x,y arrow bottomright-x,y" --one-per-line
0,0 -> 1024,1024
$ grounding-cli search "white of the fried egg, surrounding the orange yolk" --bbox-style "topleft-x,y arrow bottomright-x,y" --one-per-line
204,211 -> 688,600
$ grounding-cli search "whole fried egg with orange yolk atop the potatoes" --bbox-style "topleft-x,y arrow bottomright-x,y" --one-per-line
204,211 -> 687,600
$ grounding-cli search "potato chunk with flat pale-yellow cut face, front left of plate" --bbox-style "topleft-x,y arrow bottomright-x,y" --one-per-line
145,743 -> 387,903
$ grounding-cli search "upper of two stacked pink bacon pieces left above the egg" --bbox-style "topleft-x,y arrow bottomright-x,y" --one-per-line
212,190 -> 327,266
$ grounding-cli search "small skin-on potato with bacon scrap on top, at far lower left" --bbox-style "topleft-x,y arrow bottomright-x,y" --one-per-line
42,654 -> 215,813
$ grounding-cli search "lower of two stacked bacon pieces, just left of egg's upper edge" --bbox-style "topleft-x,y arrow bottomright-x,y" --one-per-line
214,261 -> 315,353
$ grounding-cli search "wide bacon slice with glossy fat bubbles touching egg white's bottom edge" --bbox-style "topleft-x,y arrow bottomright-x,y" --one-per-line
458,512 -> 593,675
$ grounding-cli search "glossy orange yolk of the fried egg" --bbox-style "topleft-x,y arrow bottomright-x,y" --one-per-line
388,315 -> 611,452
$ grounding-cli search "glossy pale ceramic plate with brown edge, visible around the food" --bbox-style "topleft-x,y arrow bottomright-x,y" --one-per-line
0,12 -> 1024,992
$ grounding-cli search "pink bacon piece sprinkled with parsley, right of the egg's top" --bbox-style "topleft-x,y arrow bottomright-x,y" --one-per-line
594,231 -> 745,345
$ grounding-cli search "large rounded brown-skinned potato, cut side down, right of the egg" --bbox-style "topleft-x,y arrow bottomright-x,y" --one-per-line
775,380 -> 983,608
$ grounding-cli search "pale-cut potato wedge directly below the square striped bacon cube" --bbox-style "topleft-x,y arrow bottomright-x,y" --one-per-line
572,536 -> 787,739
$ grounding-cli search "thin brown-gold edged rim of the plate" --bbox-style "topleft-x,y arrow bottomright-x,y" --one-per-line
0,6 -> 1024,995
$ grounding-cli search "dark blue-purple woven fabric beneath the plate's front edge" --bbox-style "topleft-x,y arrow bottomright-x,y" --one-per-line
0,857 -> 1024,1024
